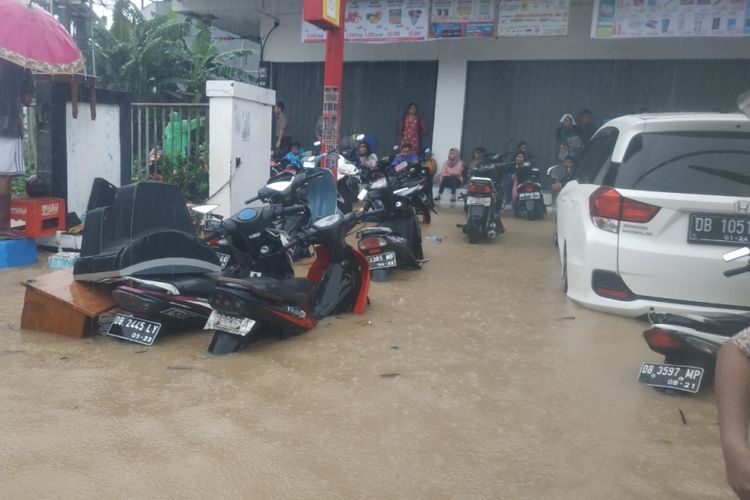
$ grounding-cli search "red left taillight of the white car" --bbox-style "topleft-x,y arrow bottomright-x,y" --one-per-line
589,186 -> 661,233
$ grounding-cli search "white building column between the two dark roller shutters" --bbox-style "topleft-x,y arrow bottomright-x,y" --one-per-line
432,52 -> 470,169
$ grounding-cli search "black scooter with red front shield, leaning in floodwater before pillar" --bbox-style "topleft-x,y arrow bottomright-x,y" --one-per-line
205,207 -> 372,354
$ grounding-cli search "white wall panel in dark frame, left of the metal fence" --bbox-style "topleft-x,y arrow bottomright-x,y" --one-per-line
65,102 -> 121,215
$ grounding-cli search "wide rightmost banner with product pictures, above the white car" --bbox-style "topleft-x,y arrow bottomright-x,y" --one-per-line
591,0 -> 750,38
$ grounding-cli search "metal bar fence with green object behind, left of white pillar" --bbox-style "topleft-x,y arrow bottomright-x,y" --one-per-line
130,102 -> 209,177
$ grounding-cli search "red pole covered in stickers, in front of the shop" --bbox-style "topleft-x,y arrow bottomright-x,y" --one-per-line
322,0 -> 346,179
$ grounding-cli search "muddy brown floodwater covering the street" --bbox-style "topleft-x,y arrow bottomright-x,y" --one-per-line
0,202 -> 732,499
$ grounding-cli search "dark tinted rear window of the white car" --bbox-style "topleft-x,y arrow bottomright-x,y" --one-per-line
614,132 -> 750,197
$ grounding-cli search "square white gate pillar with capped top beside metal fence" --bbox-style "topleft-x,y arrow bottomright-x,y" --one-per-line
206,81 -> 276,217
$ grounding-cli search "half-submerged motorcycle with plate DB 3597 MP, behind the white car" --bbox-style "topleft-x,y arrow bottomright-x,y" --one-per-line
638,247 -> 750,393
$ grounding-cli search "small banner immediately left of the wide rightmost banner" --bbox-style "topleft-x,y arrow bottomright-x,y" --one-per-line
497,0 -> 570,36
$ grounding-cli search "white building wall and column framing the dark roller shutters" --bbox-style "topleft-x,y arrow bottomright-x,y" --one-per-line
261,2 -> 750,161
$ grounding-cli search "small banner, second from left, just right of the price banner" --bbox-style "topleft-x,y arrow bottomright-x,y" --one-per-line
430,0 -> 495,39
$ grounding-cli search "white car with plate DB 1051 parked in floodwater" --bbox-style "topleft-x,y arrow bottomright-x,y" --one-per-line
556,113 -> 750,316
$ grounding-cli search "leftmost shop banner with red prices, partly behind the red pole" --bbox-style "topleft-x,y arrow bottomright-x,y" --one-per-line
302,0 -> 430,43
